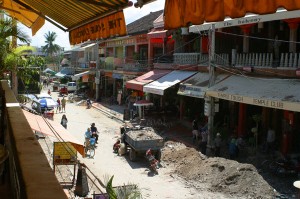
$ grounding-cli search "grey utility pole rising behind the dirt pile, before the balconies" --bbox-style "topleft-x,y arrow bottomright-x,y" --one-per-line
205,24 -> 215,154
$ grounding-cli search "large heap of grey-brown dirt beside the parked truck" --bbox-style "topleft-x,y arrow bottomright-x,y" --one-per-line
161,141 -> 275,198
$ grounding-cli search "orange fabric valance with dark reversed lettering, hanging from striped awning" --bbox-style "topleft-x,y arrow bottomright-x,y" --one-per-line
69,11 -> 126,45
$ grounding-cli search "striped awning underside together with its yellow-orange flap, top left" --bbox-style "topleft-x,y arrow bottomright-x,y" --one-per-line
0,0 -> 130,37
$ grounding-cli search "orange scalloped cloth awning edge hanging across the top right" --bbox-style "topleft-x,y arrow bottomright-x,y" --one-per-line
164,0 -> 300,30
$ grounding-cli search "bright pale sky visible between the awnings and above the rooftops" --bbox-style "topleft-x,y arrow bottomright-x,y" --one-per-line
19,0 -> 165,50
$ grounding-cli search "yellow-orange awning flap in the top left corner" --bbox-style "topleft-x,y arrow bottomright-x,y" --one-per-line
0,0 -> 45,36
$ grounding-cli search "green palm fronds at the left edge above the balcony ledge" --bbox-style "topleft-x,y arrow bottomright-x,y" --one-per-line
0,18 -> 30,75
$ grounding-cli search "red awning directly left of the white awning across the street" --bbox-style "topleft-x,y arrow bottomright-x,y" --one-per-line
126,70 -> 171,91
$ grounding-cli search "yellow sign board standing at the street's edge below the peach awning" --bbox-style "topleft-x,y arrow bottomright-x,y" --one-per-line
53,142 -> 77,165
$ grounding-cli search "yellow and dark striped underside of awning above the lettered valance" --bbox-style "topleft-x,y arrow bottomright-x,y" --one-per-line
14,0 -> 129,31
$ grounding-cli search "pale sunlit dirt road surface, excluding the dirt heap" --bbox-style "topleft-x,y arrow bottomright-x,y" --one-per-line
46,94 -> 226,199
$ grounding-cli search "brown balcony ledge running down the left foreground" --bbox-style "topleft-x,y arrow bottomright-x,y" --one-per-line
0,81 -> 67,199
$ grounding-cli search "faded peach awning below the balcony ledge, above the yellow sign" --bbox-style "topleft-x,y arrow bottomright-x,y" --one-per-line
23,110 -> 84,156
